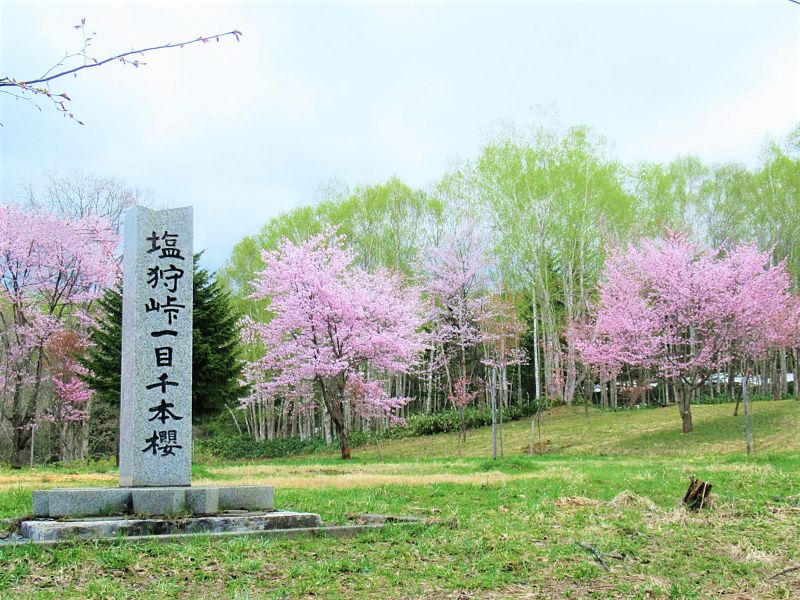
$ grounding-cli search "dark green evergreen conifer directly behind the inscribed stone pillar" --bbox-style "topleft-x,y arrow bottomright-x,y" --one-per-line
81,254 -> 247,454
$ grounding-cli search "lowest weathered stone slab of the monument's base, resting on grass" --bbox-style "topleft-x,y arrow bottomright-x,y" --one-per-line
20,511 -> 322,542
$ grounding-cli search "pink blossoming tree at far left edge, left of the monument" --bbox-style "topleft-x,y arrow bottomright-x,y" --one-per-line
0,206 -> 118,467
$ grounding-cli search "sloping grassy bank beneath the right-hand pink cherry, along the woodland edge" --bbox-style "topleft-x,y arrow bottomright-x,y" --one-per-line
346,400 -> 800,460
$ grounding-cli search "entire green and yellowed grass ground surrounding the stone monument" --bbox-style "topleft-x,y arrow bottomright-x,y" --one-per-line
0,401 -> 800,599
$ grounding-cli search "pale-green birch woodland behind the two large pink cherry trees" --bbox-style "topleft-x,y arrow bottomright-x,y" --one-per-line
220,127 -> 800,438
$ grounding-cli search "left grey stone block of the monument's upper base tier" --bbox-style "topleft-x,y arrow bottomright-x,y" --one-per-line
33,488 -> 131,517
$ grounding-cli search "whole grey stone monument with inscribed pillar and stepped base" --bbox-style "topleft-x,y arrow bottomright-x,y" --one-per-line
22,207 -> 322,539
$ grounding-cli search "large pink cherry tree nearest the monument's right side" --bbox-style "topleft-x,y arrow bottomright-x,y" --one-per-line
249,231 -> 423,459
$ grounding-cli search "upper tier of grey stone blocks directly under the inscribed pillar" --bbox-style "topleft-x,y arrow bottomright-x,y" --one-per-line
33,485 -> 275,518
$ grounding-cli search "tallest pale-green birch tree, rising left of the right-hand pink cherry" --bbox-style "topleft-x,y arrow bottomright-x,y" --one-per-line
460,127 -> 634,403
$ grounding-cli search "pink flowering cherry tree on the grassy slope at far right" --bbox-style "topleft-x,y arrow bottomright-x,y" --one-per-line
569,233 -> 796,433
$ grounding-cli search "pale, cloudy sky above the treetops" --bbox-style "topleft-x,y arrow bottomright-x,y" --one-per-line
0,0 -> 800,269
